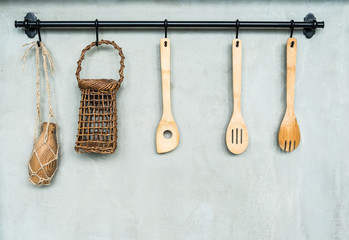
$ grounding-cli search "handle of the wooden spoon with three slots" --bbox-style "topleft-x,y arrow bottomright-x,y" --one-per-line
232,39 -> 242,112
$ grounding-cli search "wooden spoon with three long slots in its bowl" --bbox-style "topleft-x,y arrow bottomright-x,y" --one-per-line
225,39 -> 248,154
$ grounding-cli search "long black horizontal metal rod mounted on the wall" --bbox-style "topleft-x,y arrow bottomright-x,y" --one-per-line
15,21 -> 325,29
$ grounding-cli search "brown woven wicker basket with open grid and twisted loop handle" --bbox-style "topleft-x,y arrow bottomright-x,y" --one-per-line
75,40 -> 125,154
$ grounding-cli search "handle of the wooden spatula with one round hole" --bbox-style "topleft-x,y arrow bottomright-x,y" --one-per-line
160,38 -> 172,118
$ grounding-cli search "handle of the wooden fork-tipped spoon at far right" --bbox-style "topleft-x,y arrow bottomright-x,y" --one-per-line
287,38 -> 297,111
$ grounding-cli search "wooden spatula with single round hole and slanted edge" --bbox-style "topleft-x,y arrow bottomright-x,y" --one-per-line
156,38 -> 179,153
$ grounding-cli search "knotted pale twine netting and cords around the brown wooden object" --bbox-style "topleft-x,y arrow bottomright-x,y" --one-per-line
23,42 -> 59,186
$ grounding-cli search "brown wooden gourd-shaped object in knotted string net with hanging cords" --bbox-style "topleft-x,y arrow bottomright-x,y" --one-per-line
23,42 -> 59,186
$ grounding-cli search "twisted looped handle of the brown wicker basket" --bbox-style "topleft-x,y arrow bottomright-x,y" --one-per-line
75,40 -> 125,86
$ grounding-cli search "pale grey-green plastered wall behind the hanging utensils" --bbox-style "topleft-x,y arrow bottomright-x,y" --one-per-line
0,0 -> 349,240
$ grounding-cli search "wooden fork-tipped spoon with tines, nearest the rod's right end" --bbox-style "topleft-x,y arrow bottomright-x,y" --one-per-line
279,38 -> 301,152
